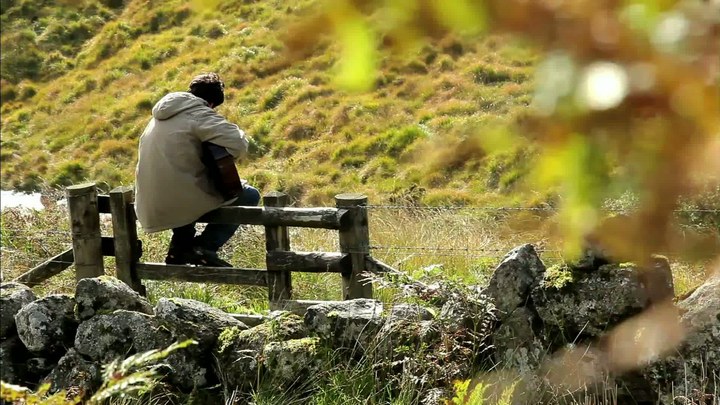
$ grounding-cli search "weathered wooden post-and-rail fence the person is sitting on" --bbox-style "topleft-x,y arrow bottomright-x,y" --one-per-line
16,183 -> 400,306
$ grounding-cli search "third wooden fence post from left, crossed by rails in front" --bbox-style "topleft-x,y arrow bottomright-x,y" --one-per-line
263,191 -> 292,304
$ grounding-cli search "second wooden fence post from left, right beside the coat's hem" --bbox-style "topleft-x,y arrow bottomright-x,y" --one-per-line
110,186 -> 145,295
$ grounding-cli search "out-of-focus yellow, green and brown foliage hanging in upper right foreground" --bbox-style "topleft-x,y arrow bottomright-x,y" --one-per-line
286,0 -> 720,261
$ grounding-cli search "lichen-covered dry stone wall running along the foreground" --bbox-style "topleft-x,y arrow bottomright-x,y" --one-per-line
0,245 -> 720,404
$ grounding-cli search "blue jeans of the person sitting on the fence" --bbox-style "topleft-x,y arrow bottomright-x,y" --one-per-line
170,184 -> 260,252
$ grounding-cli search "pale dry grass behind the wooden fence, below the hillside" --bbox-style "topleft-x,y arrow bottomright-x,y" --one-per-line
0,197 -> 710,313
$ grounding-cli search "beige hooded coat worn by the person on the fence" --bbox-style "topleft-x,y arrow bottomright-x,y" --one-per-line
135,92 -> 248,232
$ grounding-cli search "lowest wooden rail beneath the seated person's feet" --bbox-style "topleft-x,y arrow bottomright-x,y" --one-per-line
135,263 -> 267,287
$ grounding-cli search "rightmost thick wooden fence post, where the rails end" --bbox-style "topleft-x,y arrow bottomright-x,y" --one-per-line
335,193 -> 373,300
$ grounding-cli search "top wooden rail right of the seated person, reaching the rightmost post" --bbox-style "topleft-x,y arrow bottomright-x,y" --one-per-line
198,206 -> 349,229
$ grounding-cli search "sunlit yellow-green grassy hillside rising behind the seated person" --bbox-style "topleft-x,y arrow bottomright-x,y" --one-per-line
0,0 -> 544,204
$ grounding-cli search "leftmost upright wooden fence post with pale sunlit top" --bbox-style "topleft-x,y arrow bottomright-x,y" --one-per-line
65,183 -> 105,281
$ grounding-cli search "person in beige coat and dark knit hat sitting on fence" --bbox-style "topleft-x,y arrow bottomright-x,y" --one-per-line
135,73 -> 260,267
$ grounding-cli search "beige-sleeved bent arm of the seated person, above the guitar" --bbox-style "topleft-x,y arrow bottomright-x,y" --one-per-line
193,108 -> 248,159
